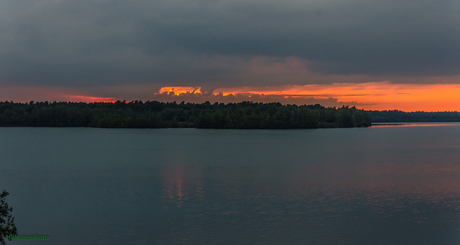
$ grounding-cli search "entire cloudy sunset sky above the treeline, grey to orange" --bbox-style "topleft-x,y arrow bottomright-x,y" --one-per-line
0,0 -> 460,111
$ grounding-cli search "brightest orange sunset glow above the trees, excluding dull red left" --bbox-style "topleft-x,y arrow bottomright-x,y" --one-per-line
160,81 -> 460,111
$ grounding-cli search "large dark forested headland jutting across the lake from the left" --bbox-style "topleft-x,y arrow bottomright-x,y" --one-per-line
0,101 -> 370,129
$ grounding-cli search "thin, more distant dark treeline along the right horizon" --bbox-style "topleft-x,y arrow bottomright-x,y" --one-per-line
368,110 -> 460,122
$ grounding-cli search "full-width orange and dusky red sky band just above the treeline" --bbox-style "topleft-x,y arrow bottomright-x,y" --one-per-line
0,81 -> 460,111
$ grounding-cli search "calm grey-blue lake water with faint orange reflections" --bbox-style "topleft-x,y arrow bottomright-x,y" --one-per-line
0,123 -> 460,245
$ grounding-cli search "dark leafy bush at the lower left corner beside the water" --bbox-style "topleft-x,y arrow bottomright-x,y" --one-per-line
0,190 -> 18,245
